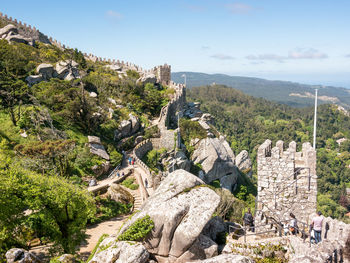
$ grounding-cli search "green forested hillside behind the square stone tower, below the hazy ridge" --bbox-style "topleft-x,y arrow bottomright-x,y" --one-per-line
187,85 -> 350,220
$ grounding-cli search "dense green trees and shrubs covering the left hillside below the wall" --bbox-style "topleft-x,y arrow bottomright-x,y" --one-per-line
0,37 -> 174,261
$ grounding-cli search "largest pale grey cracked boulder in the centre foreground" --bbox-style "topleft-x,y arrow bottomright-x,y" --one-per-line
115,170 -> 220,263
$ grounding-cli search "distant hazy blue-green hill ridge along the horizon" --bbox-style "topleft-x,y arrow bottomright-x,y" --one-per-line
172,72 -> 350,109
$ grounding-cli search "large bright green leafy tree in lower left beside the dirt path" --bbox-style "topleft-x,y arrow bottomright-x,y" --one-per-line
0,159 -> 95,258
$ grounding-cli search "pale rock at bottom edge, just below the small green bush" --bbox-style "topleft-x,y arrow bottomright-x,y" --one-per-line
89,237 -> 149,263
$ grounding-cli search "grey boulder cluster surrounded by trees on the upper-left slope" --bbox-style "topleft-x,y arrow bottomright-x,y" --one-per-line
26,60 -> 80,86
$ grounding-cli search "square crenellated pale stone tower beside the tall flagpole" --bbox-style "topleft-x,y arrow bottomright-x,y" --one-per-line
255,140 -> 317,227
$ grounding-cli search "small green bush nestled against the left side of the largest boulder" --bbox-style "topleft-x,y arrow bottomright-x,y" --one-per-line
118,215 -> 154,241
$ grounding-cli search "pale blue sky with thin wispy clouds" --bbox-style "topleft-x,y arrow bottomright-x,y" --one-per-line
0,0 -> 350,88
